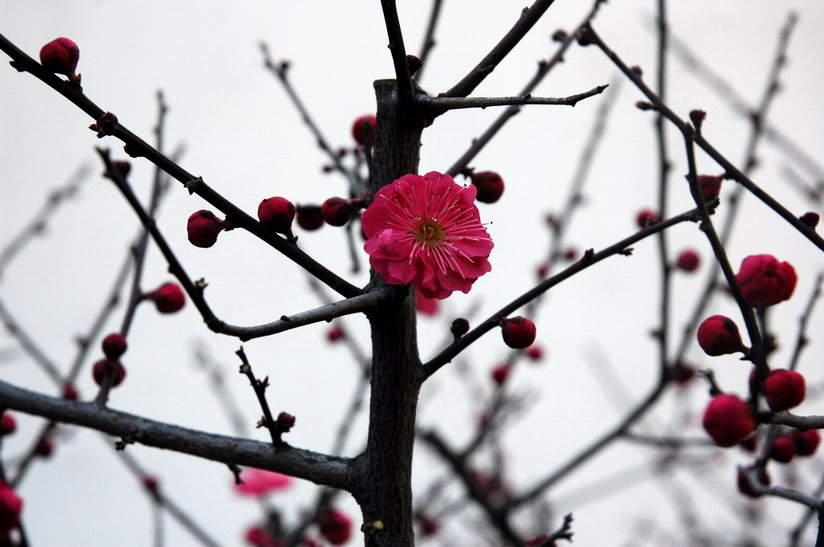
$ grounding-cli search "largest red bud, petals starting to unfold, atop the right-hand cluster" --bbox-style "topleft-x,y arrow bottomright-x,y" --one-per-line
735,255 -> 798,308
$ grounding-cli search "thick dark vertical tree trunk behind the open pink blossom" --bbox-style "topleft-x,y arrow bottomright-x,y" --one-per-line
354,80 -> 424,546
